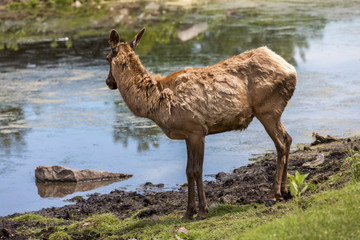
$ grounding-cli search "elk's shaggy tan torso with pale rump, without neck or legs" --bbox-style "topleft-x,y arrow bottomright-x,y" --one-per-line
158,47 -> 296,133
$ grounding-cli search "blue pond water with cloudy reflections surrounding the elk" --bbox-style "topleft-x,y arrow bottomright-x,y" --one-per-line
0,1 -> 360,215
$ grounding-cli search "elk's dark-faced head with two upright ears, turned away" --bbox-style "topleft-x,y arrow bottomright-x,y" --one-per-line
106,28 -> 145,90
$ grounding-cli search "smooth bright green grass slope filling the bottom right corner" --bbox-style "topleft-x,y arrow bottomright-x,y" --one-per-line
242,183 -> 360,239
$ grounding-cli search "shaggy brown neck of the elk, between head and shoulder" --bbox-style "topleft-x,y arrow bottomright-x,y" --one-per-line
113,53 -> 161,119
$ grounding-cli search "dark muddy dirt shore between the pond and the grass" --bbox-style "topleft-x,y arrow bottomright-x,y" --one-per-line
0,136 -> 360,239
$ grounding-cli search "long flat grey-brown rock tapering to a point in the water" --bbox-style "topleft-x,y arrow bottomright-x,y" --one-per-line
35,166 -> 132,182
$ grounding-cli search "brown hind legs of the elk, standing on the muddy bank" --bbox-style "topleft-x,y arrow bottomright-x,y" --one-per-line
256,112 -> 292,201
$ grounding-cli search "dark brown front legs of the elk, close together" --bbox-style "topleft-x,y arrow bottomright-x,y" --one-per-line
185,135 -> 208,219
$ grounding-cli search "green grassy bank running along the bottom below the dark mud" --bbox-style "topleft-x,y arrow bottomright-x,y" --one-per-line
6,153 -> 360,239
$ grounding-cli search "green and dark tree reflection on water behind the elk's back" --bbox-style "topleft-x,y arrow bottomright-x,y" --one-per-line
136,3 -> 327,73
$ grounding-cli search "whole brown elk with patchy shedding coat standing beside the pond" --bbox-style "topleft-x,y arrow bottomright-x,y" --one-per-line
106,28 -> 296,219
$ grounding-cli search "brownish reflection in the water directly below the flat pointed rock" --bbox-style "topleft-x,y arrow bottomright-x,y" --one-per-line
36,179 -> 125,198
